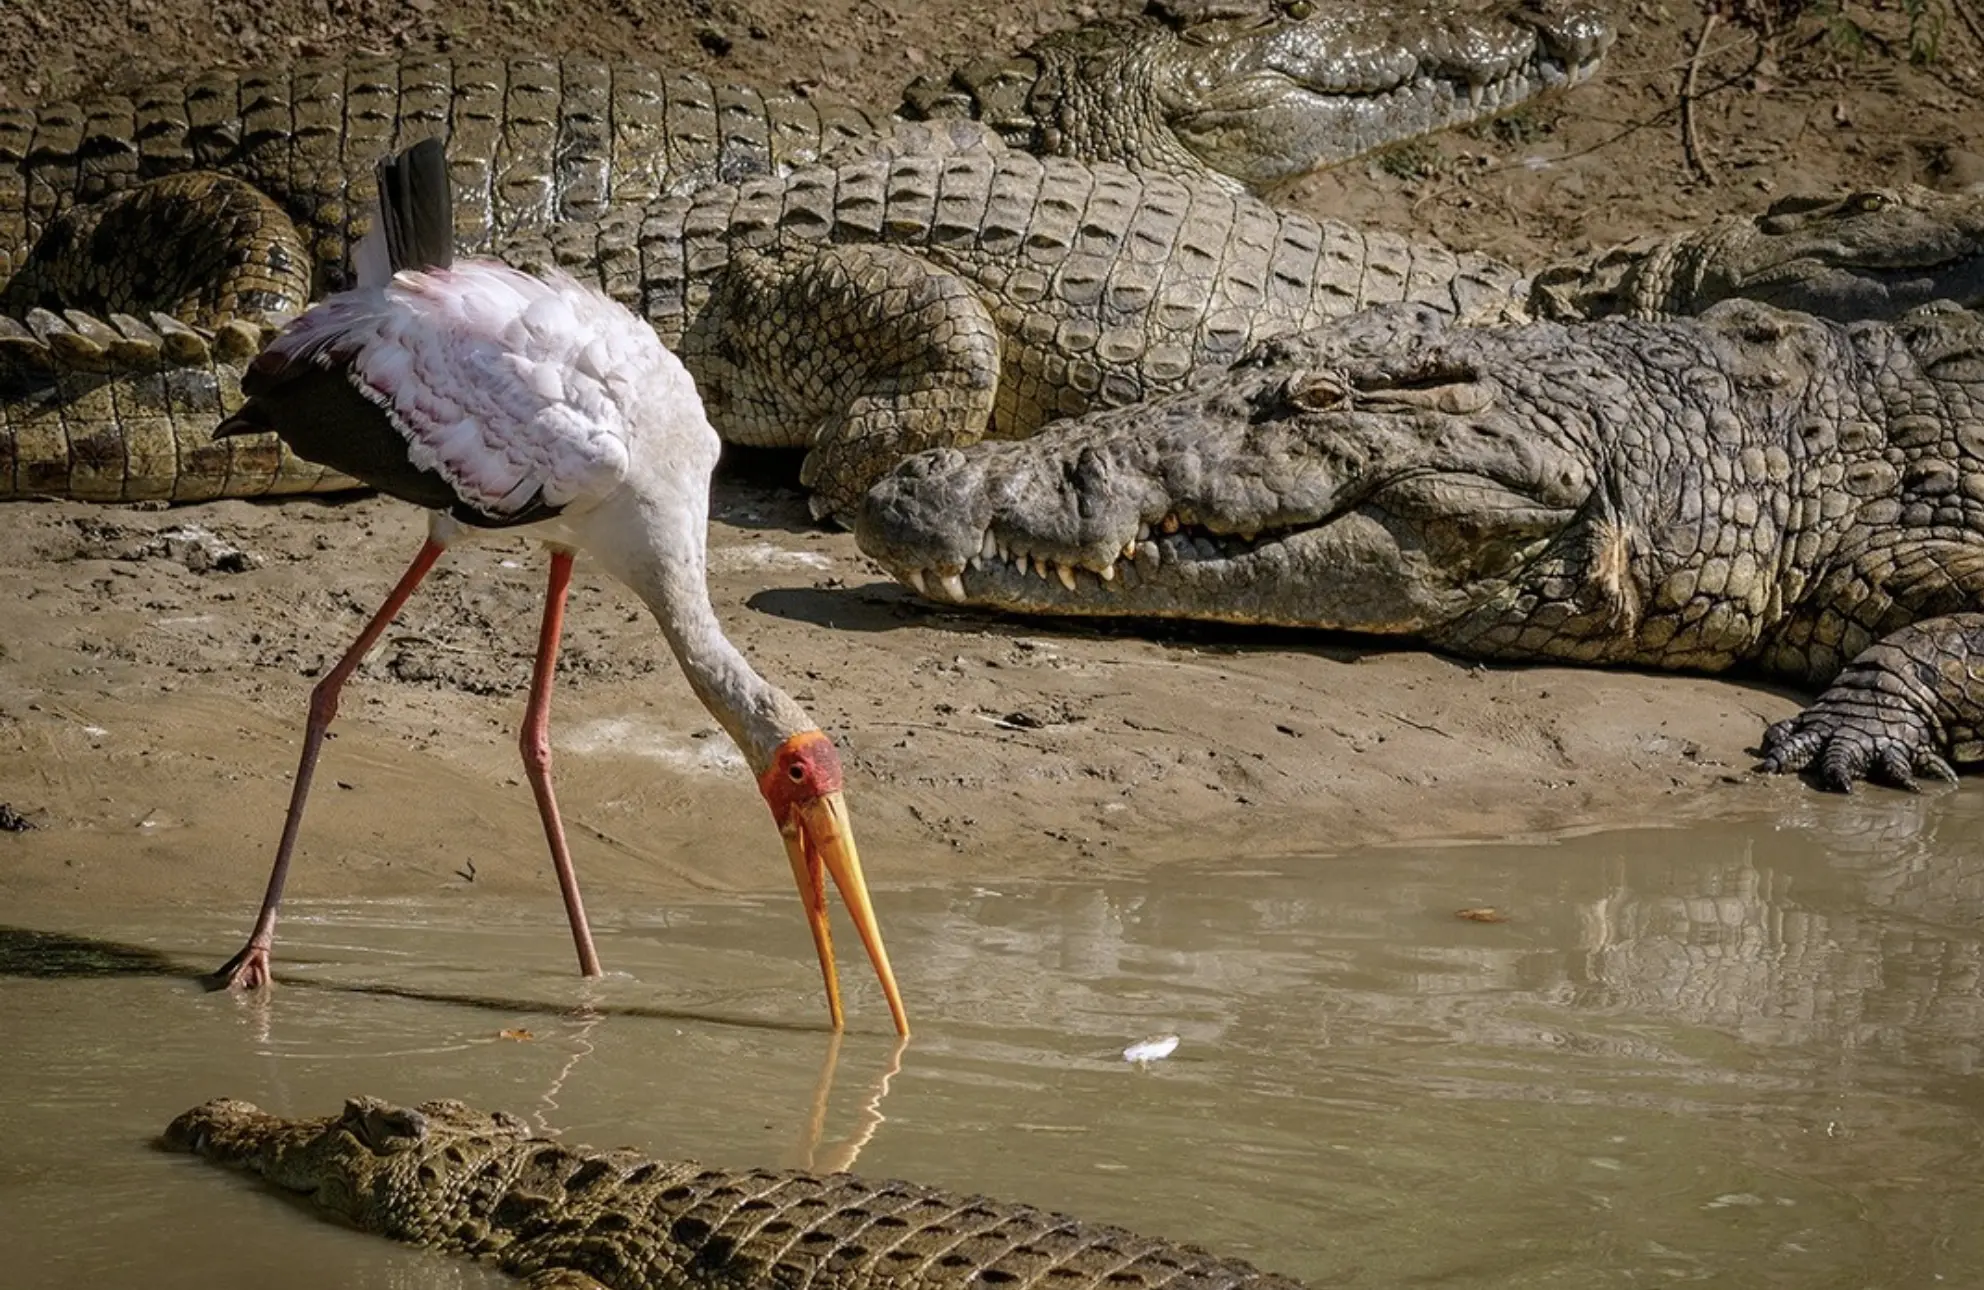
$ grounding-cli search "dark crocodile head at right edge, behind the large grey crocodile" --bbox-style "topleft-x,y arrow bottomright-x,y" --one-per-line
1530,187 -> 1984,322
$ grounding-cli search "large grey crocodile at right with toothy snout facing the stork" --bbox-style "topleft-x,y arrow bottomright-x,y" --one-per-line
855,300 -> 1984,790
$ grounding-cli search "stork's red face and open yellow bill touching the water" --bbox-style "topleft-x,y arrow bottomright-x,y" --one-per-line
758,730 -> 909,1034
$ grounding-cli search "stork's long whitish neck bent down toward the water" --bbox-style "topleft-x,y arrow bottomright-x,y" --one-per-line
623,519 -> 815,776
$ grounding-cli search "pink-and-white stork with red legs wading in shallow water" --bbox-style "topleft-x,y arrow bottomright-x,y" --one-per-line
216,141 -> 909,1034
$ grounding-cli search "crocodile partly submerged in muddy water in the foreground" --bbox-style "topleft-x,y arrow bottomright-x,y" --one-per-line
163,1097 -> 1300,1290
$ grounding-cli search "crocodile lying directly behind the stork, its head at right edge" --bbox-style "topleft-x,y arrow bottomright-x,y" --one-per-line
0,171 -> 1984,514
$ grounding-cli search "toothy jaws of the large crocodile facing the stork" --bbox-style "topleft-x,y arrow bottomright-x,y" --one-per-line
855,426 -> 1585,635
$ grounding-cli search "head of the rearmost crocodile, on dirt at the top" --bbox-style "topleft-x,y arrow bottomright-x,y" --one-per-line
905,0 -> 1613,191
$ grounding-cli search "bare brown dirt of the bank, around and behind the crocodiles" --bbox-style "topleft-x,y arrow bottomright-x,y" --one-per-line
0,0 -> 1984,917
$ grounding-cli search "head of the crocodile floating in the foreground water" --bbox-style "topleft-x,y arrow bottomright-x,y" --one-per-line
163,1097 -> 528,1234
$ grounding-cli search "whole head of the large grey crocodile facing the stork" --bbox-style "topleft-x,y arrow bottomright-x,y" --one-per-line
855,306 -> 1597,635
